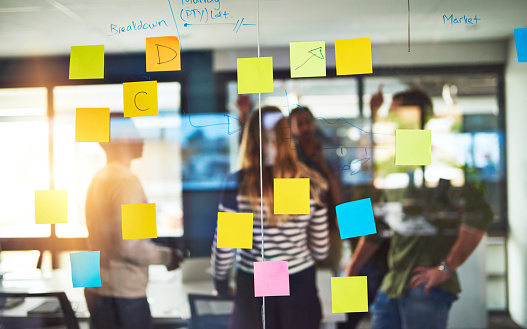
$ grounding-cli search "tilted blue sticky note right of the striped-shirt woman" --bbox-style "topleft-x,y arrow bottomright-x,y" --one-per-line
335,198 -> 377,239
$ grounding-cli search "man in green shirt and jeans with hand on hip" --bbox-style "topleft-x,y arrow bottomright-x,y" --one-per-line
345,90 -> 492,329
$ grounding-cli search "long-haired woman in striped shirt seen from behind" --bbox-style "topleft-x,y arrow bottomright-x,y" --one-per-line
211,106 -> 329,329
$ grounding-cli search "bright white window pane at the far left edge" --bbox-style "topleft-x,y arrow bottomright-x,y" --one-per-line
0,88 -> 51,238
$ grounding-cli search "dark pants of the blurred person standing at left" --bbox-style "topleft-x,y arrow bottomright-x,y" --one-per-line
84,289 -> 153,329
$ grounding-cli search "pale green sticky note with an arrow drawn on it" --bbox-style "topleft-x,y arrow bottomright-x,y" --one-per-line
289,41 -> 326,78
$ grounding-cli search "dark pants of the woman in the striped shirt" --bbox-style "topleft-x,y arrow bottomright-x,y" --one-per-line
229,266 -> 322,329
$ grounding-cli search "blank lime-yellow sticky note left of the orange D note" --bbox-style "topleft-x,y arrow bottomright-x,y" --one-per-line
70,45 -> 104,79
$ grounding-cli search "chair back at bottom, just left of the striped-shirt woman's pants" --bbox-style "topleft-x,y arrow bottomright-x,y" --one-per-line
188,294 -> 234,329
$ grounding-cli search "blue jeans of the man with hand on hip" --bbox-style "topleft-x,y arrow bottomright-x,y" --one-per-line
371,285 -> 457,329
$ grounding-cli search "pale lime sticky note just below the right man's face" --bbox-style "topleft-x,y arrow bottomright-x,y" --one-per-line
395,129 -> 432,166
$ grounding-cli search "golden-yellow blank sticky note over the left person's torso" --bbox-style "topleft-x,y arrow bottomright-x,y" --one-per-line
121,203 -> 157,239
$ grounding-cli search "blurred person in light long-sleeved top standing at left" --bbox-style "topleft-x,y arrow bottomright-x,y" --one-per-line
84,113 -> 182,329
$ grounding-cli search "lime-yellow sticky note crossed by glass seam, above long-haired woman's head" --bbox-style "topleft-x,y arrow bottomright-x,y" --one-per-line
237,57 -> 274,94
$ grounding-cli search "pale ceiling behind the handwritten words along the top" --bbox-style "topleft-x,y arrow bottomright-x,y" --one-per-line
0,0 -> 527,57
